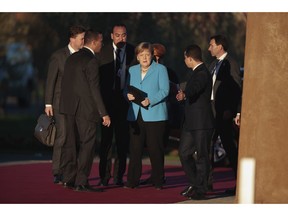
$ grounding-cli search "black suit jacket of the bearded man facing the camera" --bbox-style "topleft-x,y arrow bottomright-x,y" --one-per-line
99,42 -> 136,112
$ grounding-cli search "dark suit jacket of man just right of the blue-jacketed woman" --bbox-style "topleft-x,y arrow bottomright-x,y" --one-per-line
183,64 -> 214,130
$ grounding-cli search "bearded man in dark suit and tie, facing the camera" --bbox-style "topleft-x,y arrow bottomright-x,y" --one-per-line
99,24 -> 134,186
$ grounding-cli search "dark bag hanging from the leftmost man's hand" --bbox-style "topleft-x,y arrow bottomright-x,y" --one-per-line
34,114 -> 56,147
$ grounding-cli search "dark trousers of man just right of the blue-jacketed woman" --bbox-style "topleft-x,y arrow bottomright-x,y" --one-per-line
179,129 -> 213,193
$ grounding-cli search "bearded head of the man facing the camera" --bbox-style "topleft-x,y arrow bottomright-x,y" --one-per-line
111,24 -> 127,48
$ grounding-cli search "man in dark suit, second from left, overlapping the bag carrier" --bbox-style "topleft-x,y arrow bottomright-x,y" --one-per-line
60,30 -> 110,191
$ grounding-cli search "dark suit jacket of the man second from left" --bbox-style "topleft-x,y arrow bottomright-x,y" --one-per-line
60,48 -> 107,122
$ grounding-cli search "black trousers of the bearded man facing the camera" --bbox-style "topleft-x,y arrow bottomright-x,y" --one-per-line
99,91 -> 129,183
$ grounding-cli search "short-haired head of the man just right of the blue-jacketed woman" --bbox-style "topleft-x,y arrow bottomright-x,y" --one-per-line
184,44 -> 202,68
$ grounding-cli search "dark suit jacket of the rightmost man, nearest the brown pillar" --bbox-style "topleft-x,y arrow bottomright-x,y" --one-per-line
210,54 -> 242,117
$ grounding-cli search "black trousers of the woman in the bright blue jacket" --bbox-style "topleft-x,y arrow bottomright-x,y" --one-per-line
127,112 -> 166,187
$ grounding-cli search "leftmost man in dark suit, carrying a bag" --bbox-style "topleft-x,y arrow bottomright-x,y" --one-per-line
45,26 -> 85,184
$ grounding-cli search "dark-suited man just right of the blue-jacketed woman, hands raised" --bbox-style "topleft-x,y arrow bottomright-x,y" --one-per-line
176,45 -> 214,200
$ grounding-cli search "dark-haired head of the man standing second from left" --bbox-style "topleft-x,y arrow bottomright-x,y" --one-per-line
84,29 -> 103,53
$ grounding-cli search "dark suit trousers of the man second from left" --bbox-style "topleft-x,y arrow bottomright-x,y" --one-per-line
62,115 -> 97,185
